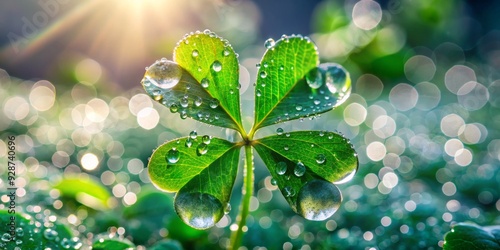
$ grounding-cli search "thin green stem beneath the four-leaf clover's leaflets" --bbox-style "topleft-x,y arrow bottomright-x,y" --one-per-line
231,144 -> 254,249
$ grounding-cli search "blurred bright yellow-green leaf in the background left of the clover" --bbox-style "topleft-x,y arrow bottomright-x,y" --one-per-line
54,176 -> 111,210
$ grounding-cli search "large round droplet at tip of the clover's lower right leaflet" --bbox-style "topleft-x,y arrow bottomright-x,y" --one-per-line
297,180 -> 342,221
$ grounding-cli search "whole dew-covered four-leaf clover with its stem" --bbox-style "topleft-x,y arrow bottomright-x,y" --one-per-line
141,30 -> 358,248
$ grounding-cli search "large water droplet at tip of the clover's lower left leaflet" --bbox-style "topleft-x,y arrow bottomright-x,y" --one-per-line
174,192 -> 224,229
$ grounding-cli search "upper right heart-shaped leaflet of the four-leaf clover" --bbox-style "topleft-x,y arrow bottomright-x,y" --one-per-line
254,36 -> 351,129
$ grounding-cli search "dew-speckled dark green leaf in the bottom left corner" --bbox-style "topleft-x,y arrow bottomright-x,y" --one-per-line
0,210 -> 78,249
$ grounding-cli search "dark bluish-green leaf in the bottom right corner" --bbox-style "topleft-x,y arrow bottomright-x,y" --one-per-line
443,223 -> 500,250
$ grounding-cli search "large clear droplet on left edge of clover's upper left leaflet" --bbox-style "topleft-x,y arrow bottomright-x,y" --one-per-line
142,59 -> 182,89
